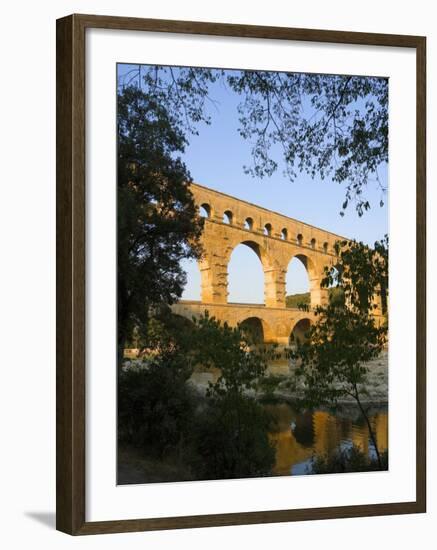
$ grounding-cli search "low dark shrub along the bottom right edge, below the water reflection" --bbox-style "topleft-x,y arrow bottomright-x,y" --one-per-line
308,445 -> 388,474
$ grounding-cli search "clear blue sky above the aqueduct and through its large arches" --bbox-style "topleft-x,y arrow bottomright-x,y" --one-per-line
119,65 -> 388,303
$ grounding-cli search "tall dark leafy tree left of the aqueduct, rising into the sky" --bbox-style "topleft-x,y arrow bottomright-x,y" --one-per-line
117,87 -> 202,364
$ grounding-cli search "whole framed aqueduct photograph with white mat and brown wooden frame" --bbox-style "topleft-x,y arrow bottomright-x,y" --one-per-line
56,15 -> 426,535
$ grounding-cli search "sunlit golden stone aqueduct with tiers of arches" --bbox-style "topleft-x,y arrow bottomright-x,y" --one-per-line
173,183 -> 358,345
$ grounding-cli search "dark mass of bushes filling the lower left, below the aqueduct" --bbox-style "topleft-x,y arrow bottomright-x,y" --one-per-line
118,314 -> 275,479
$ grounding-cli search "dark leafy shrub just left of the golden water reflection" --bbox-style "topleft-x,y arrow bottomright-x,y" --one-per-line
186,315 -> 275,479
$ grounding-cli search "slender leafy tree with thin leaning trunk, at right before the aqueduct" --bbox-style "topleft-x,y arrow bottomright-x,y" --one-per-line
292,241 -> 388,467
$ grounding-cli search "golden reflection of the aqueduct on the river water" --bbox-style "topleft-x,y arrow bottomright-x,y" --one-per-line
266,403 -> 388,475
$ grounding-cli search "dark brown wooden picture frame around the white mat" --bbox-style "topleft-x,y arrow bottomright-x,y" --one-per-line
56,15 -> 426,535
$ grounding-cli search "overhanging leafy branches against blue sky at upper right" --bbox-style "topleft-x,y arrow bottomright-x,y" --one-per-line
228,71 -> 388,216
